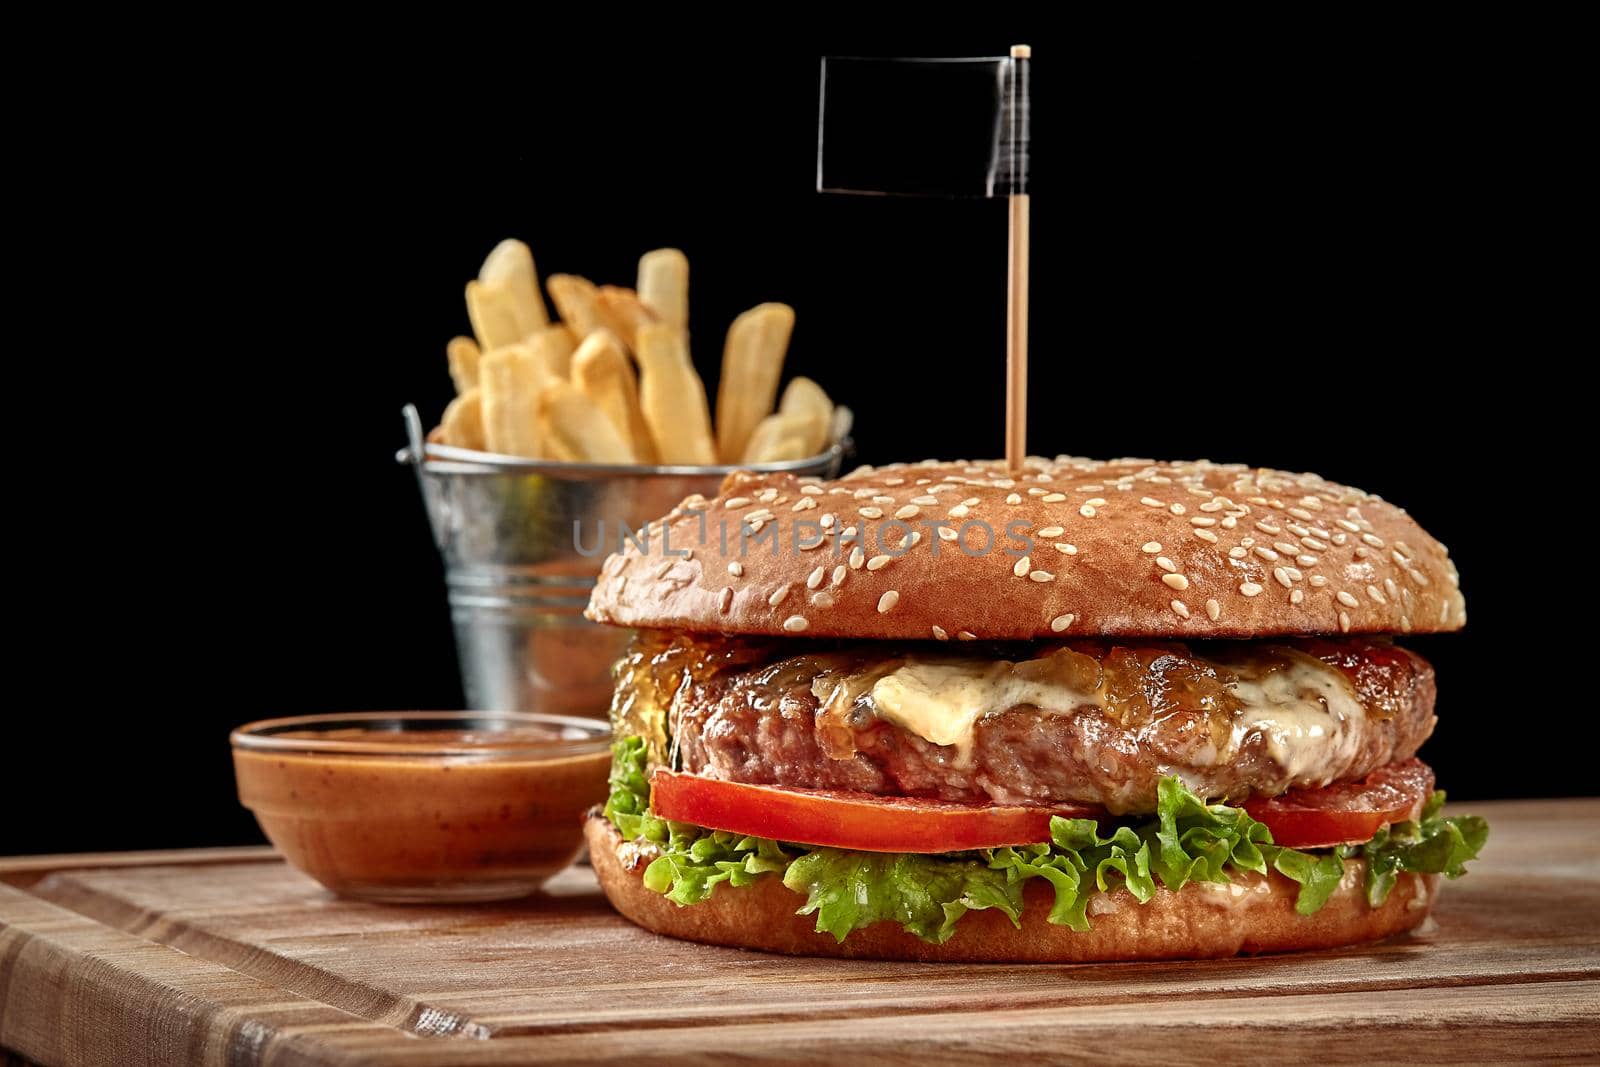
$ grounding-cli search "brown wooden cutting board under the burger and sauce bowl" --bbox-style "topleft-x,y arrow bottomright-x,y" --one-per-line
0,800 -> 1600,1067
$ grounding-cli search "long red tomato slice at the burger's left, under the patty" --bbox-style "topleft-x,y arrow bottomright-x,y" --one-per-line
650,771 -> 1106,853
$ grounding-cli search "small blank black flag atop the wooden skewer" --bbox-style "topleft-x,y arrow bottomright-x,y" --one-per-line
816,53 -> 1029,197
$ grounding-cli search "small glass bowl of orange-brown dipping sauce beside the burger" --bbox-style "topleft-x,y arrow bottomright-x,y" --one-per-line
230,712 -> 611,902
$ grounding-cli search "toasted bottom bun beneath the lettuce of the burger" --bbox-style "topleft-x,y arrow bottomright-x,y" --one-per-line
584,816 -> 1438,963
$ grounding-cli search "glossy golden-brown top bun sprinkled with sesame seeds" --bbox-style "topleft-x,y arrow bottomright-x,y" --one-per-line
587,456 -> 1467,640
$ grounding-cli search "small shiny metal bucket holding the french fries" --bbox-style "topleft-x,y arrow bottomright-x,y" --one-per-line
395,405 -> 848,718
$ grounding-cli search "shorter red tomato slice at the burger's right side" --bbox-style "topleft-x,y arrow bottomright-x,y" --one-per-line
1243,760 -> 1434,848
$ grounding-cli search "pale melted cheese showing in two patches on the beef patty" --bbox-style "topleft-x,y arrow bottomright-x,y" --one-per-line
857,656 -> 1368,781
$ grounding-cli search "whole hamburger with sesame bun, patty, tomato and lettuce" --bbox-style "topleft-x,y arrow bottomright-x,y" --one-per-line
586,456 -> 1488,961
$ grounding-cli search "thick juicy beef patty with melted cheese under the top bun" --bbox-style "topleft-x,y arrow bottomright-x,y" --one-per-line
618,635 -> 1435,813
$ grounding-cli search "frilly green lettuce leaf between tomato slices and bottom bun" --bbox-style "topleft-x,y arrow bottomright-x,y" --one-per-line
605,737 -> 1488,944
